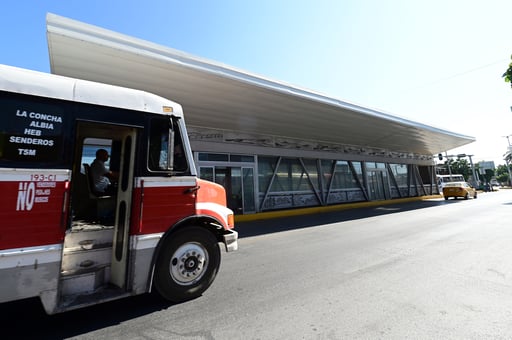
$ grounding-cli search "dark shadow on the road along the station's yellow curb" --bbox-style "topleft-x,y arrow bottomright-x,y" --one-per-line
235,199 -> 450,238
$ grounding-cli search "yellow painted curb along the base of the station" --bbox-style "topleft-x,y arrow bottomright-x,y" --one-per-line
235,195 -> 443,225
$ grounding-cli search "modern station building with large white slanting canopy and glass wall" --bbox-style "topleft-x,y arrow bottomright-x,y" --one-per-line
47,14 -> 475,214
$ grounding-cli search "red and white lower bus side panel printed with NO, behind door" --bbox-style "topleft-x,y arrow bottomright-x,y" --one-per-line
0,169 -> 69,302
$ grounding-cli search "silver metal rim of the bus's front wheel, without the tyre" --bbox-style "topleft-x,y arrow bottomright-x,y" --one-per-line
169,243 -> 208,286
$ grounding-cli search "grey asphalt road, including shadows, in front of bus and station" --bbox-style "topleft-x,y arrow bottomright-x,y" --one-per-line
0,190 -> 512,339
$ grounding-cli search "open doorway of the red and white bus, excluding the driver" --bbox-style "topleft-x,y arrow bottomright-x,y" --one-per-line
71,122 -> 137,289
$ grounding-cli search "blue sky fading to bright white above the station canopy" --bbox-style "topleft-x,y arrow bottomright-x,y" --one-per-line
0,0 -> 512,165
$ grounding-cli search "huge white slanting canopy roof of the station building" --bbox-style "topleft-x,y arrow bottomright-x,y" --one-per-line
47,14 -> 475,155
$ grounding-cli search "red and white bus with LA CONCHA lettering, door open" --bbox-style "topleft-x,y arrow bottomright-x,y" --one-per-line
0,65 -> 238,314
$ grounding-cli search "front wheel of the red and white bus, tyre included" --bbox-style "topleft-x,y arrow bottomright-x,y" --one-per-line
154,227 -> 220,302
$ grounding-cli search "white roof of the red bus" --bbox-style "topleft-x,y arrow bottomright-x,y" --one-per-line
0,64 -> 183,117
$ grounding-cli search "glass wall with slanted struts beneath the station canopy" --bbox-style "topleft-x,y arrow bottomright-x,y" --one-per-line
196,152 -> 439,214
